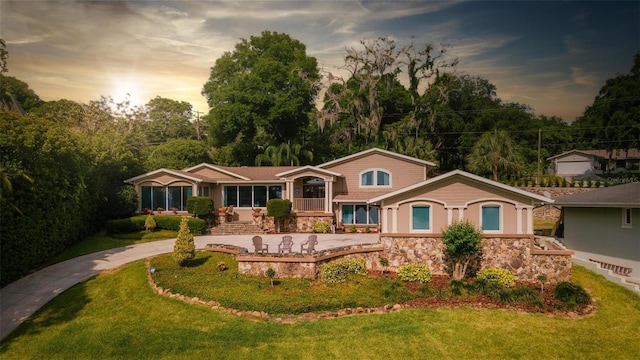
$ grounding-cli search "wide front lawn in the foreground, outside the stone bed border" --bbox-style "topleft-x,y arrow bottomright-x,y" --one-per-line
0,261 -> 640,360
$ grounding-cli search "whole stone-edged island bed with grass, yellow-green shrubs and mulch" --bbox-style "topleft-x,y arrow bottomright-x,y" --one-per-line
150,252 -> 593,315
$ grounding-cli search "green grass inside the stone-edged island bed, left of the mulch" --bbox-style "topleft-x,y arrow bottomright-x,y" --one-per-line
151,252 -> 414,314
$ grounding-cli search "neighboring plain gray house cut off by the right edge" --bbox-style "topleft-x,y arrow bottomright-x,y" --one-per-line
554,182 -> 640,278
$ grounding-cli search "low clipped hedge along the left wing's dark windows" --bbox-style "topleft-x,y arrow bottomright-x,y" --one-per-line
106,215 -> 207,234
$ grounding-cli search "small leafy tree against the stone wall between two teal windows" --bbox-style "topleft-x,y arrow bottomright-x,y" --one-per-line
442,221 -> 482,280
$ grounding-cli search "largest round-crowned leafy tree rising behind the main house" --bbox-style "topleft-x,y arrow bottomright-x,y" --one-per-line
202,31 -> 319,165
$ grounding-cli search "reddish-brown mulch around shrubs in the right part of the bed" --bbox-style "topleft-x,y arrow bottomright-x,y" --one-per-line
369,271 -> 596,318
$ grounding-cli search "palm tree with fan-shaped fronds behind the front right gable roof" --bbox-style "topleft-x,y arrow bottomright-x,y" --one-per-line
467,129 -> 522,181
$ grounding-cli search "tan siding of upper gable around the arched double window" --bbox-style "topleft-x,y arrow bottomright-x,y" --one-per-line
326,154 -> 426,193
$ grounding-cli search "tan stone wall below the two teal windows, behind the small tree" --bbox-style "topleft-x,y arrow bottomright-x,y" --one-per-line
380,235 -> 572,283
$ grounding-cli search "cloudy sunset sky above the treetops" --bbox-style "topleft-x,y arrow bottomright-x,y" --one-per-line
0,0 -> 640,122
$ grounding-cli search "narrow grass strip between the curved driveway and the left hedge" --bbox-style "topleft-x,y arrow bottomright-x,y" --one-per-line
45,230 -> 178,266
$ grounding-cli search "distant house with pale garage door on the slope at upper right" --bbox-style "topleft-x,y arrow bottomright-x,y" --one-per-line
547,149 -> 640,177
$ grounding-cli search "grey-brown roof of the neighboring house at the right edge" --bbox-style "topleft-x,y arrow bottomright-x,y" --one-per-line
554,182 -> 640,208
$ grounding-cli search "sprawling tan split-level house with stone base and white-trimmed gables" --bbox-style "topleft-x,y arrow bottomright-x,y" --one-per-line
127,148 -> 573,282
